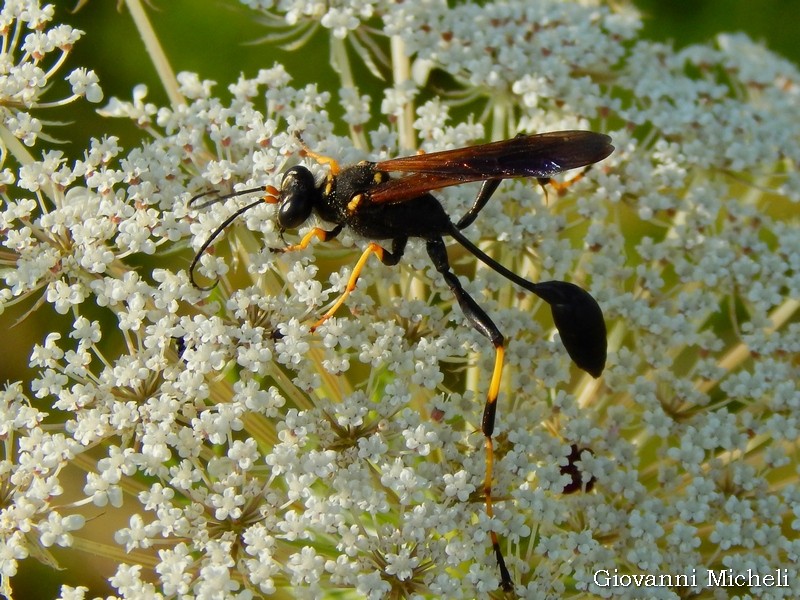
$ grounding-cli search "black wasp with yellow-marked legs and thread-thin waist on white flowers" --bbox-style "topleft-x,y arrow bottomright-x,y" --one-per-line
189,131 -> 614,591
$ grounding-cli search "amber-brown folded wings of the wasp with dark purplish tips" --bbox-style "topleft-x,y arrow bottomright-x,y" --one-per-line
367,131 -> 614,203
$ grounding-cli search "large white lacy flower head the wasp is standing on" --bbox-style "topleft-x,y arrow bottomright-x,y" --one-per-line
0,0 -> 800,600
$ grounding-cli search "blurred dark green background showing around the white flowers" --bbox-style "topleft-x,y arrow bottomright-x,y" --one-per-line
0,0 -> 800,598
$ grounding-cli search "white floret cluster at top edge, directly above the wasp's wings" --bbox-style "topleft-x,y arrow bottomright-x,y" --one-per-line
385,0 -> 640,101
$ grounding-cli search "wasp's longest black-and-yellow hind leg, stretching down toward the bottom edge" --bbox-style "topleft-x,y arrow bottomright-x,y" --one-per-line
427,238 -> 514,591
